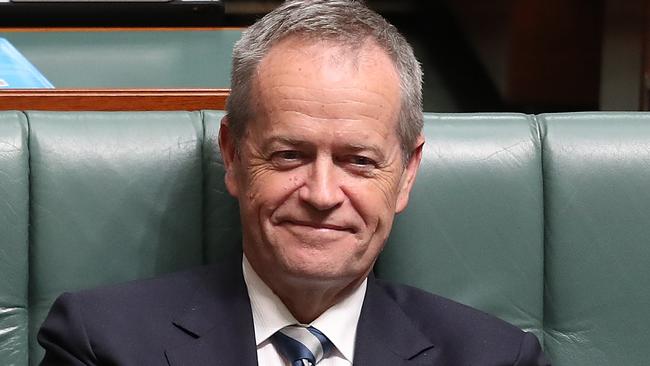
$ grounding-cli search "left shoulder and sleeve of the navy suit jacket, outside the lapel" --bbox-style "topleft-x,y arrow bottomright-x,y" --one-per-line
38,267 -> 232,365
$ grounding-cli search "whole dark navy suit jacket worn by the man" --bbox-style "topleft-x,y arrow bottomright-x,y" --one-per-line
38,260 -> 548,366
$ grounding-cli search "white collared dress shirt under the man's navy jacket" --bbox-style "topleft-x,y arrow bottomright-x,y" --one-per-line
242,256 -> 368,366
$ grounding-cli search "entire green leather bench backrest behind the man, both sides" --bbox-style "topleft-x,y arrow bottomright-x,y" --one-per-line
0,111 -> 650,366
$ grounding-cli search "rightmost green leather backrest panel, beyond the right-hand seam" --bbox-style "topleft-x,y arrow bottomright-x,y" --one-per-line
540,113 -> 650,366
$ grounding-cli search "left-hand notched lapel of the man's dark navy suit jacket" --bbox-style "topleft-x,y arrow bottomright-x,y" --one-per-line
165,261 -> 257,366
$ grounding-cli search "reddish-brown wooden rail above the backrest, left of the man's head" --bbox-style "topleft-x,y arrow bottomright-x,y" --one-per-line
0,89 -> 229,111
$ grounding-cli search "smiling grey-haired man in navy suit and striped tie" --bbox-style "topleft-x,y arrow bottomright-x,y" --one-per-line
39,0 -> 546,366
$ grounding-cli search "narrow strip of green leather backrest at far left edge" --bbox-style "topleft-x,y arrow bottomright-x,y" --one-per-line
0,112 -> 29,366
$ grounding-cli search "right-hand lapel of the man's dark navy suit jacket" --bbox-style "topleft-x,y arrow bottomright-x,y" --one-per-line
353,275 -> 440,366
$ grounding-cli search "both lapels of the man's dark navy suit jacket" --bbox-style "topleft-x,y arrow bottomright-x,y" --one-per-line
165,261 -> 440,366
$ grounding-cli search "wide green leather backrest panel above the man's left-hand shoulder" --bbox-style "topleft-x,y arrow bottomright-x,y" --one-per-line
27,112 -> 203,364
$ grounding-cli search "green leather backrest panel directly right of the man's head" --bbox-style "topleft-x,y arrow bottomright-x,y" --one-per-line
377,114 -> 544,340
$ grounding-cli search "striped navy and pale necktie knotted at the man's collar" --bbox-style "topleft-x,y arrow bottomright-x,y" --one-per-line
271,325 -> 334,366
